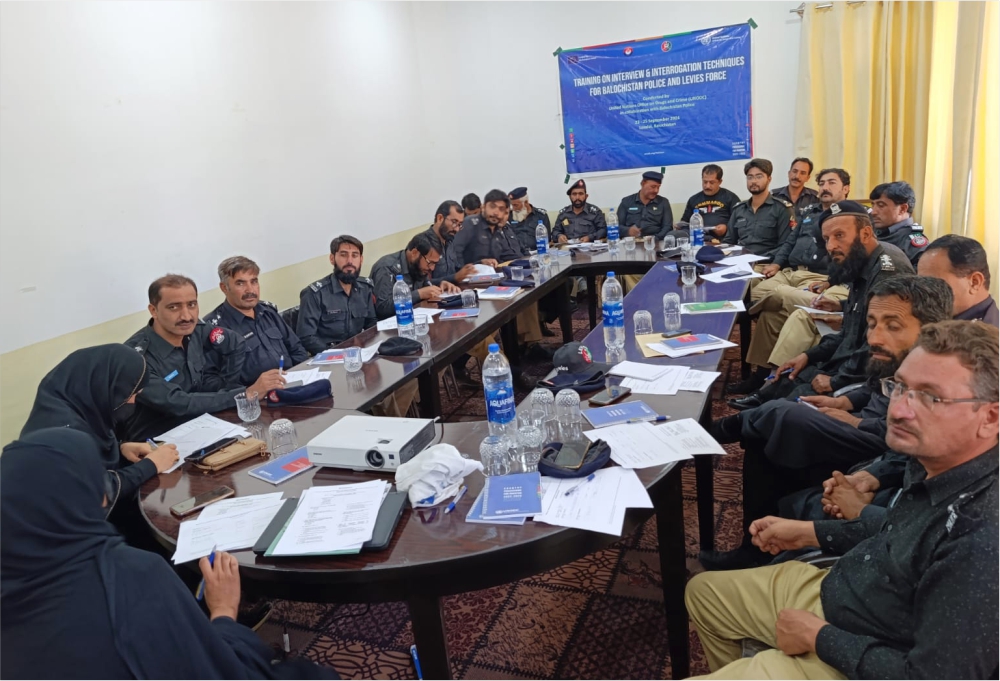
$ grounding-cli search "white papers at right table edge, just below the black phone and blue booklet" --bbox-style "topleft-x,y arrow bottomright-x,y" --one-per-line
584,419 -> 726,470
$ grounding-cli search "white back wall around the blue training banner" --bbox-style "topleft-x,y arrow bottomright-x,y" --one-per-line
414,1 -> 801,212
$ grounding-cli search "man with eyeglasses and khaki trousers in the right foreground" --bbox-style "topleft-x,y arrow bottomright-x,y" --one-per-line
686,321 -> 1000,679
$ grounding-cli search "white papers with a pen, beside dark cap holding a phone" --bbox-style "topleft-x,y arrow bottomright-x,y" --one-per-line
534,468 -> 653,536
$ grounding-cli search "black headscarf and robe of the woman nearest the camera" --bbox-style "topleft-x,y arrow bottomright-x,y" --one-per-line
0,428 -> 336,679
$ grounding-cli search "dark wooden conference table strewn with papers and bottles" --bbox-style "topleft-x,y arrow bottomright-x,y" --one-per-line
139,246 -> 745,678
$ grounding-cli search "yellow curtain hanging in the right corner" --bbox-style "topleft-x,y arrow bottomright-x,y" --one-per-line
794,2 -> 1000,295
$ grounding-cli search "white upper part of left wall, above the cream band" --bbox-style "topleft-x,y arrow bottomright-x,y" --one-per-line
0,2 -> 436,352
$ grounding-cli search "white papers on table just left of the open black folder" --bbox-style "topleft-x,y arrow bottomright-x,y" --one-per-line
172,492 -> 284,563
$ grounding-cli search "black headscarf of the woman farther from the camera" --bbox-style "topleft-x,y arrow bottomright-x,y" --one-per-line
21,343 -> 149,469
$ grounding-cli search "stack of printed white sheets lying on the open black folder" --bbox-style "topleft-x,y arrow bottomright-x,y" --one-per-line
273,480 -> 387,556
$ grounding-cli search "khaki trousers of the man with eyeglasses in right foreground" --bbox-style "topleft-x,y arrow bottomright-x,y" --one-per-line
684,560 -> 845,679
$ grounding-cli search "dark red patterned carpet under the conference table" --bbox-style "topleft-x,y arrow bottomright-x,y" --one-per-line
260,305 -> 742,679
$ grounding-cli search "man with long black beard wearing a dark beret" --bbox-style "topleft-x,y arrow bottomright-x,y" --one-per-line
730,201 -> 913,409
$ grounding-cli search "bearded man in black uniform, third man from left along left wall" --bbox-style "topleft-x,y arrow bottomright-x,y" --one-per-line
295,234 -> 378,354
